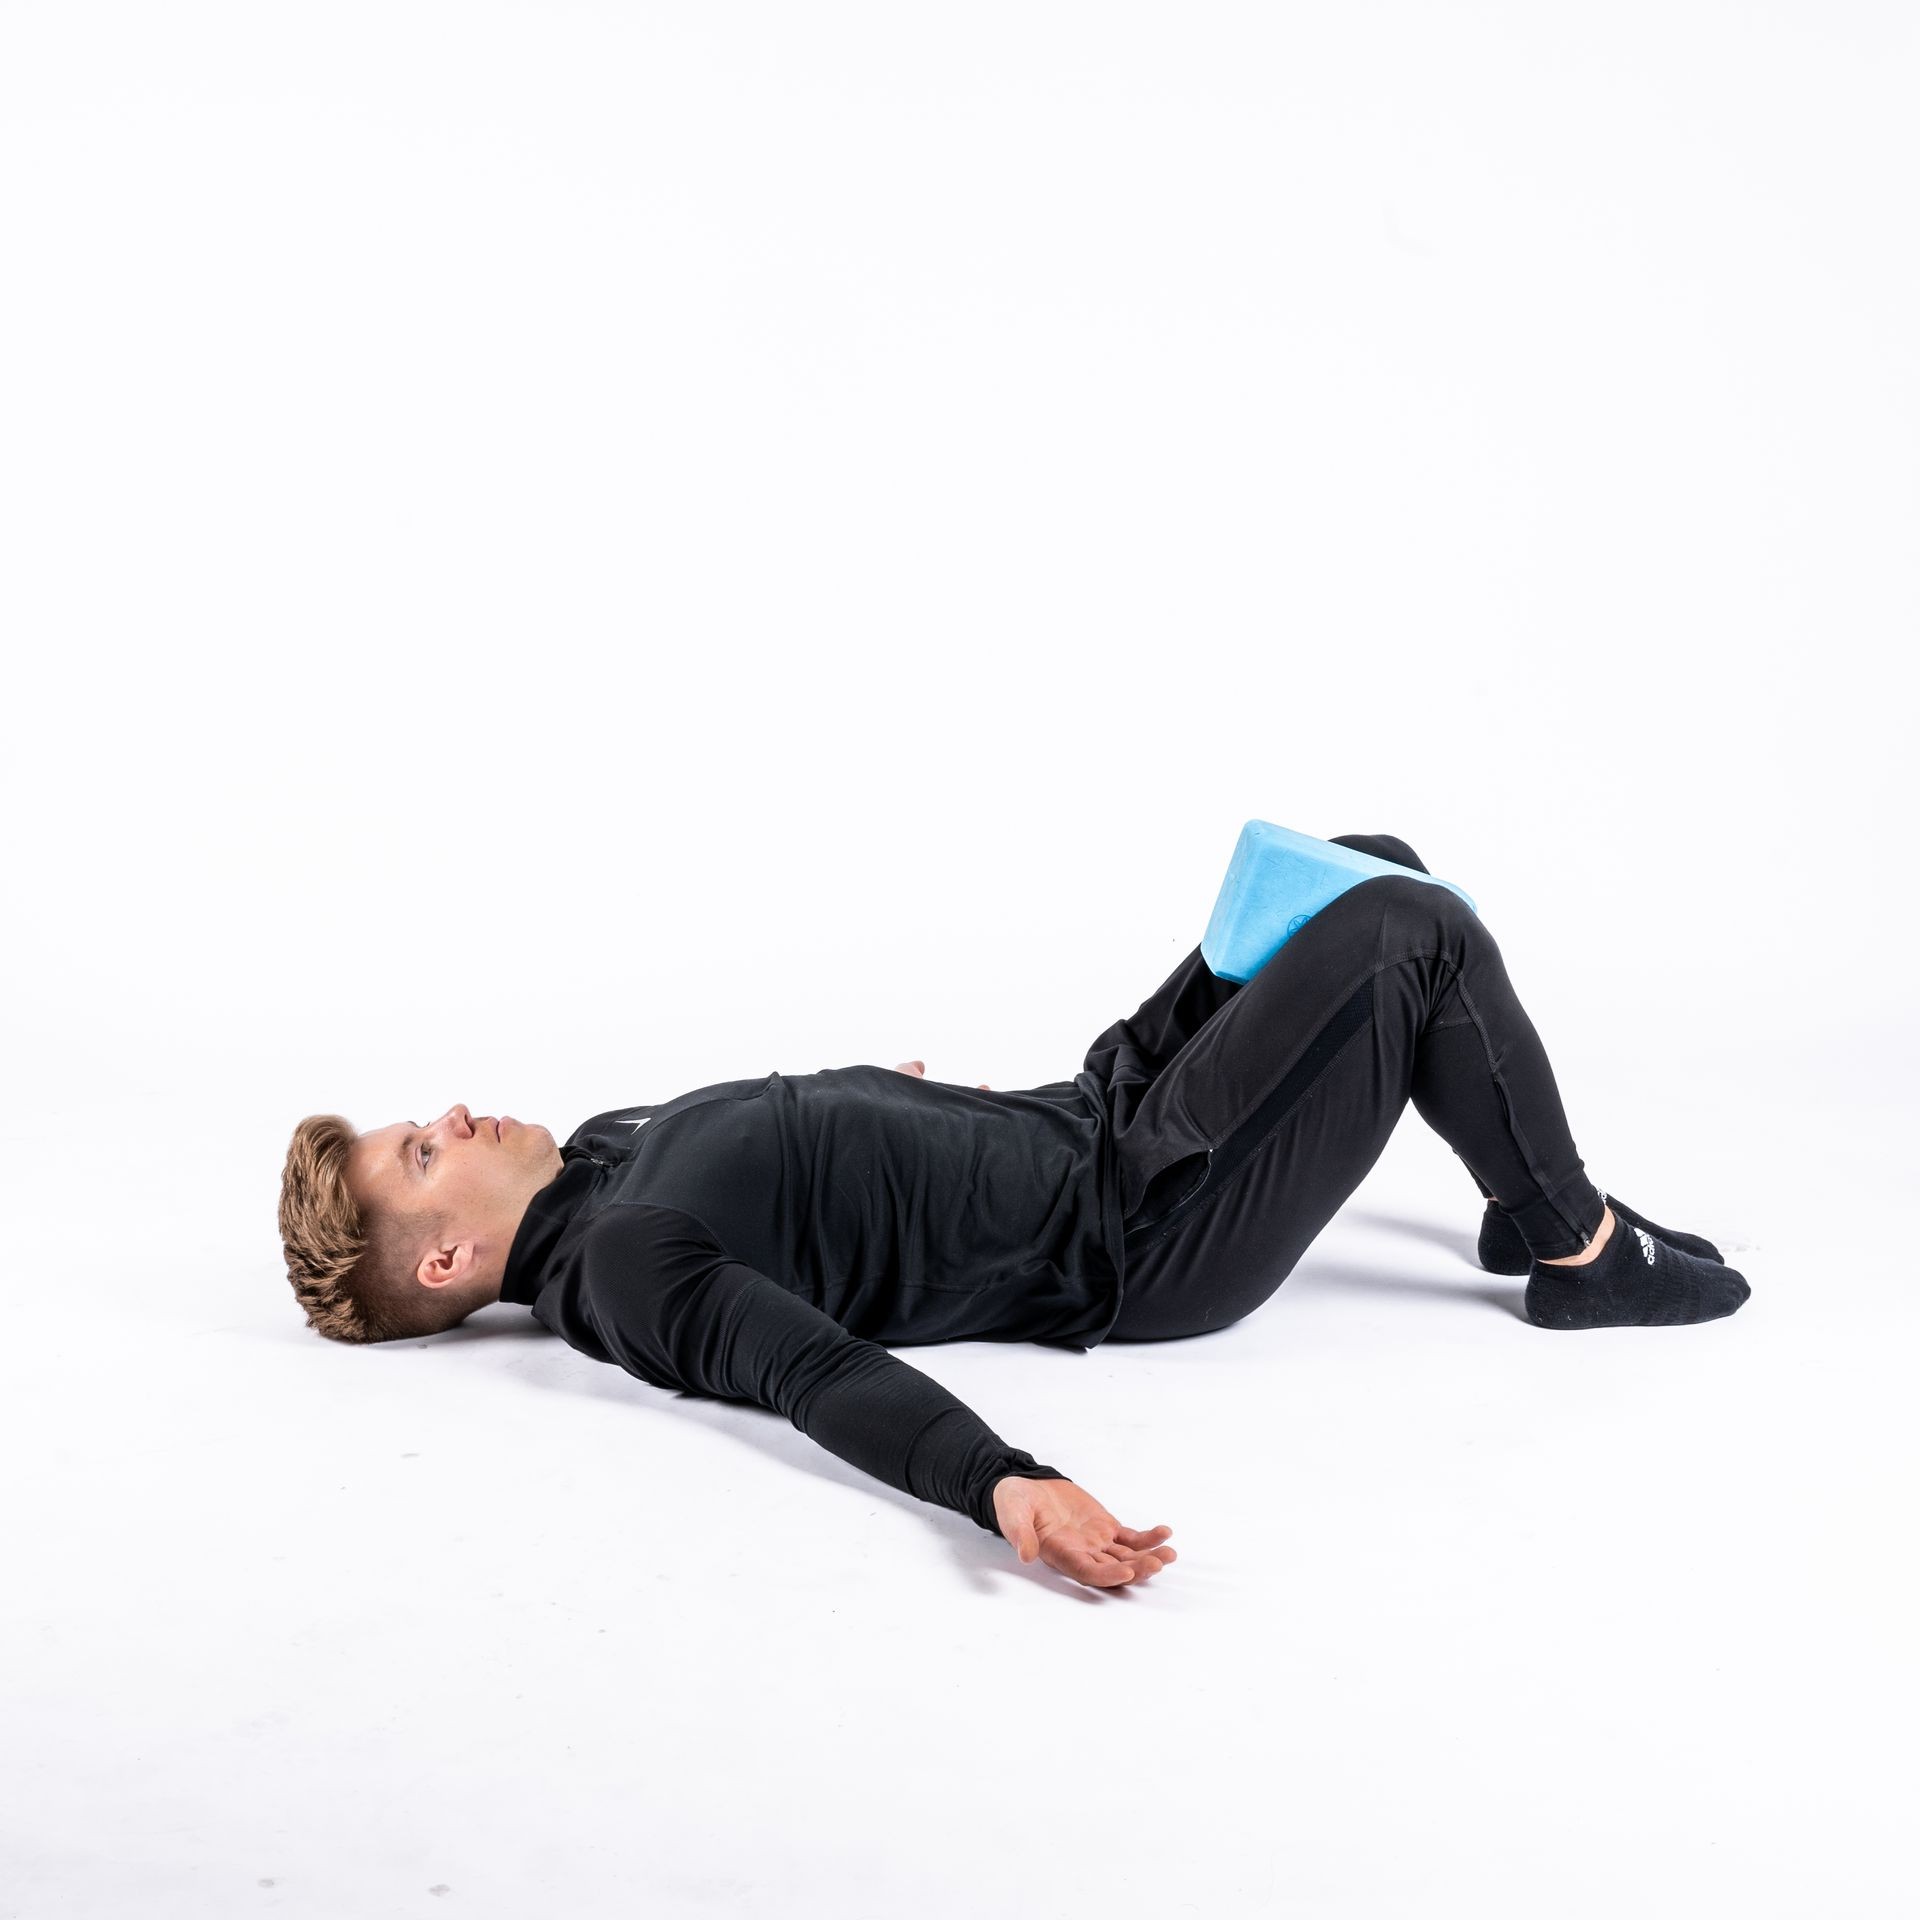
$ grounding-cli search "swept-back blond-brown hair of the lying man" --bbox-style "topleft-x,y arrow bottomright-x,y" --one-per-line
280,1114 -> 451,1346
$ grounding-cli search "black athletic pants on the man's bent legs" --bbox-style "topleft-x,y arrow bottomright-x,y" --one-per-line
1087,833 -> 1605,1340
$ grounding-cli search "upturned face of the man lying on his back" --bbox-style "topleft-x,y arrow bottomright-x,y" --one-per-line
348,1106 -> 561,1300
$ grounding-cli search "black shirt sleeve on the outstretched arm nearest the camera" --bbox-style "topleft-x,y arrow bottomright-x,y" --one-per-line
584,1202 -> 1068,1536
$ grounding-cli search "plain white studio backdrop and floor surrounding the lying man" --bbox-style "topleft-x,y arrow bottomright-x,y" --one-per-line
0,0 -> 1920,1920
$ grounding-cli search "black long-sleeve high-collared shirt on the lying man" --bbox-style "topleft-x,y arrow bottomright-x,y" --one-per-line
501,1066 -> 1123,1534
